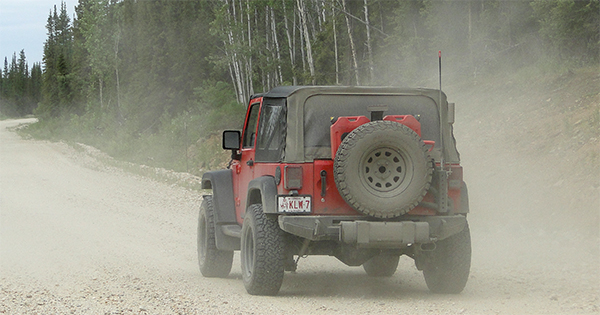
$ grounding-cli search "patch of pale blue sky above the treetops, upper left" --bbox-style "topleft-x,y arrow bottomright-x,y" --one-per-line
0,0 -> 77,69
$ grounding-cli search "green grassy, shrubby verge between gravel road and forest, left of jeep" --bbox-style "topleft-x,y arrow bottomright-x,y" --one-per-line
17,100 -> 245,190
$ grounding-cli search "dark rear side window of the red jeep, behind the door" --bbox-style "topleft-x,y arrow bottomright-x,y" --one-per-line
256,98 -> 286,162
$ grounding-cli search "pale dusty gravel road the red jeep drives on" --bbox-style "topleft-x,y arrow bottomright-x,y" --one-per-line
0,116 -> 600,314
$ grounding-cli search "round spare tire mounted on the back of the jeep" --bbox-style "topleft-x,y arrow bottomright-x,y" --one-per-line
333,121 -> 433,218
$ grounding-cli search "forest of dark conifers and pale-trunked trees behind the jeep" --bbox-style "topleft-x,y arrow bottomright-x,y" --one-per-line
0,0 -> 600,173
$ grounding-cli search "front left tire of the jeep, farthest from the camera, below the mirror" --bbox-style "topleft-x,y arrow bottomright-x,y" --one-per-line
197,196 -> 233,278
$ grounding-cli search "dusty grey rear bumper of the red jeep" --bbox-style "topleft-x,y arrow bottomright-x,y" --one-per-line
279,215 -> 467,248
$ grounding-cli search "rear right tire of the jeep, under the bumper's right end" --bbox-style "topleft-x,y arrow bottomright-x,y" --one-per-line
419,225 -> 471,294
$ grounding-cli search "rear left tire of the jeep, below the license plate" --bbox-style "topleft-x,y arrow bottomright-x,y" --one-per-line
240,204 -> 284,295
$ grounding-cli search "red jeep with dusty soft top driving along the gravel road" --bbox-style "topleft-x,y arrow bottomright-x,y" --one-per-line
198,86 -> 471,295
